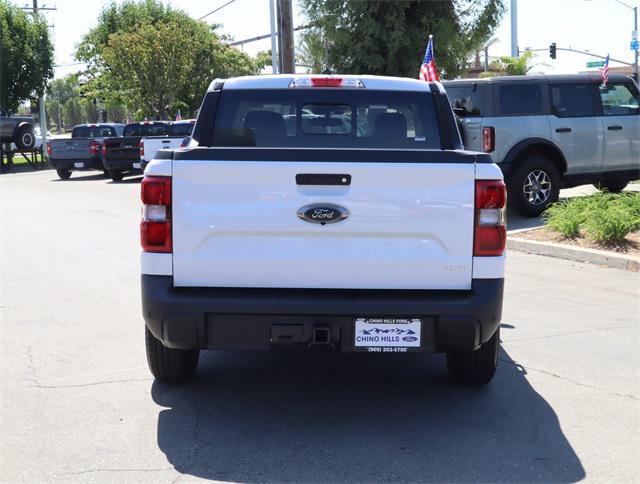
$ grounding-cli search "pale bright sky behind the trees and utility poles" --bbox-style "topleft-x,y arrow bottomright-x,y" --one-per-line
13,0 -> 640,77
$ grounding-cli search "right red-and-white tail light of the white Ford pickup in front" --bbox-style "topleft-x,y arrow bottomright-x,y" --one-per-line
473,180 -> 507,256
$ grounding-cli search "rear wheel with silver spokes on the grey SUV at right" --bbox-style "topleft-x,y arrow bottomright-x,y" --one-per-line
507,156 -> 560,217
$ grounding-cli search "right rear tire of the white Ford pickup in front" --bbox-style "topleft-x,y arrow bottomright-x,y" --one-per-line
447,328 -> 500,386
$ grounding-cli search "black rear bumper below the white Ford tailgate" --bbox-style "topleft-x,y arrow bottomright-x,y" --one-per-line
142,274 -> 504,352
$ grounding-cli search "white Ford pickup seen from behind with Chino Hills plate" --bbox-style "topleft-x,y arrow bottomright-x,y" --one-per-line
140,75 -> 506,385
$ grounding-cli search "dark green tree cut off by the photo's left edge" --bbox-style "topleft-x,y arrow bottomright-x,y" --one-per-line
0,0 -> 53,112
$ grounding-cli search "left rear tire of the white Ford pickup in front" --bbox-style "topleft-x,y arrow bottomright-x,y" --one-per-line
144,326 -> 200,383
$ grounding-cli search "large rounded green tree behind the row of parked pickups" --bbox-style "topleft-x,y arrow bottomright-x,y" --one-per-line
76,0 -> 259,118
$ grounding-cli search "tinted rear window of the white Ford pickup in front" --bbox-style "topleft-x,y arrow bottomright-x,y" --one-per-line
213,88 -> 440,149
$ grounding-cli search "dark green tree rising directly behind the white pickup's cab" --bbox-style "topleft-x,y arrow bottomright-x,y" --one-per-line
302,0 -> 505,78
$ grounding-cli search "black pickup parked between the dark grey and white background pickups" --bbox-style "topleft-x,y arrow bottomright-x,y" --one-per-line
102,121 -> 171,181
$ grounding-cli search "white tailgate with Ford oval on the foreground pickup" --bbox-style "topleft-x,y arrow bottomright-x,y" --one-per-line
172,157 -> 475,290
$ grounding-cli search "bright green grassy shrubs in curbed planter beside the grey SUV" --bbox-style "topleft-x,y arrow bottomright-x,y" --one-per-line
543,193 -> 640,244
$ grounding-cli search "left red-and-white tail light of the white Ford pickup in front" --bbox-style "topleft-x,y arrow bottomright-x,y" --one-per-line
140,176 -> 172,253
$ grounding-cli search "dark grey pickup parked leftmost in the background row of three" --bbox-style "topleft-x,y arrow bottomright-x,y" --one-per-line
47,123 -> 124,180
